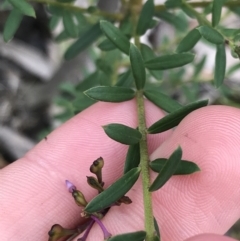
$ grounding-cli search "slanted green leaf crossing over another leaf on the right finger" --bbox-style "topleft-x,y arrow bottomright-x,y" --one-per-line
149,146 -> 182,192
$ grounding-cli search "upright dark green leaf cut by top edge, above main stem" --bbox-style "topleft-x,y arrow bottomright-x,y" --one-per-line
136,0 -> 154,36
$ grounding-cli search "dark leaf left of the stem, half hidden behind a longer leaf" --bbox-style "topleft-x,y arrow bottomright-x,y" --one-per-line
124,143 -> 140,173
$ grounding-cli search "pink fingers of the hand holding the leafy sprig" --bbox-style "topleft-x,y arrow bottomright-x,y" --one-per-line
0,100 -> 240,241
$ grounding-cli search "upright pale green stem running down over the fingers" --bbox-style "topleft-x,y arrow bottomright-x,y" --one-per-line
136,90 -> 155,241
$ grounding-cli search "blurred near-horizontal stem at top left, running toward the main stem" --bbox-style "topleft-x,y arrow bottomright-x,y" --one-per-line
27,0 -> 123,21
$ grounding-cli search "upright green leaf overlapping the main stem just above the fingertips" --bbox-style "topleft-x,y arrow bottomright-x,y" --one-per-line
129,44 -> 146,90
